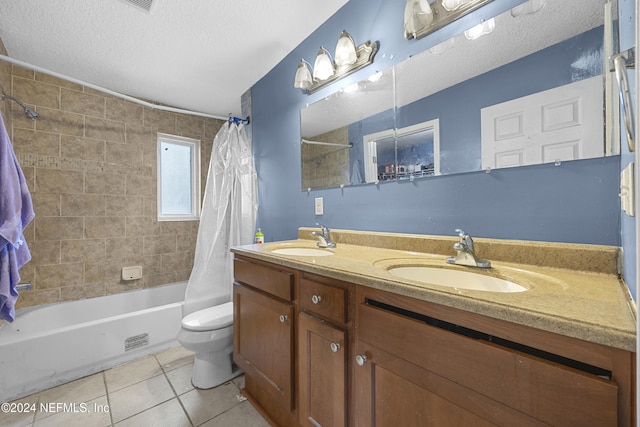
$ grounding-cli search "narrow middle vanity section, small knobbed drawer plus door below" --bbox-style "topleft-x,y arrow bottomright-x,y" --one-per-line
297,273 -> 353,427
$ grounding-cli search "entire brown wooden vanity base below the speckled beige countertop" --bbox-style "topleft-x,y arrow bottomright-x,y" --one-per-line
234,255 -> 635,427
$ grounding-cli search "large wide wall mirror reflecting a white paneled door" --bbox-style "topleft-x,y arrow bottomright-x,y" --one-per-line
300,0 -> 618,190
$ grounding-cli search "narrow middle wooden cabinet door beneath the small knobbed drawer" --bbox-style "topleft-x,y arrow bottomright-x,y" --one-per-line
298,313 -> 347,427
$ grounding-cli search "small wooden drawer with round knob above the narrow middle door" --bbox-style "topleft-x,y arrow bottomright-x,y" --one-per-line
298,275 -> 348,325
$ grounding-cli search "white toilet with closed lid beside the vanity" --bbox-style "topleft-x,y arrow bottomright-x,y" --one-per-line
178,302 -> 242,388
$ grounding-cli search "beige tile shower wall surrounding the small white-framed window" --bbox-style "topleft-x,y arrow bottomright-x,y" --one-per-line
0,61 -> 224,307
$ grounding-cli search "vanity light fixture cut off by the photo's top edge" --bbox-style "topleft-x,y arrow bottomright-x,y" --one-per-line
404,0 -> 493,40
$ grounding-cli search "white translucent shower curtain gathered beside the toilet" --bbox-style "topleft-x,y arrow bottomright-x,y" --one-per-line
183,122 -> 258,315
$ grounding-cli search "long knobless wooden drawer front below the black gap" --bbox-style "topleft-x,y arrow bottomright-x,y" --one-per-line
358,304 -> 618,426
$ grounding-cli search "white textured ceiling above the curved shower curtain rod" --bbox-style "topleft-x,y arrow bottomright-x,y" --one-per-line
0,0 -> 347,116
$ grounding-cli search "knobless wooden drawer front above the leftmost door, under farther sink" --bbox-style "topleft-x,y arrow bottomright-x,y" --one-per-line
233,258 -> 295,301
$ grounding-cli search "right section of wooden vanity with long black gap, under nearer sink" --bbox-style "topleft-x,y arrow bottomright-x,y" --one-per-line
353,287 -> 634,427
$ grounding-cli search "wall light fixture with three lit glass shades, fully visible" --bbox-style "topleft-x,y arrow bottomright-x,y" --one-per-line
293,29 -> 378,93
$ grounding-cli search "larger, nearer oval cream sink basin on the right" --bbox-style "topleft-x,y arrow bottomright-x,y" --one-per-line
387,266 -> 527,292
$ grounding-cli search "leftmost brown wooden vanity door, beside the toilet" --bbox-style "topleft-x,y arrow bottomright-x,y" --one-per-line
233,284 -> 293,411
